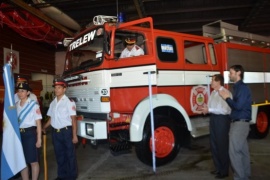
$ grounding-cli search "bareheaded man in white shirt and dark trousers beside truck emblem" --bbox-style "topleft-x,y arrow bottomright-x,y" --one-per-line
198,74 -> 232,179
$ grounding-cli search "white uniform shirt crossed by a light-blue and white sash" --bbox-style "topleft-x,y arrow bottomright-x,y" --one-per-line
16,98 -> 42,128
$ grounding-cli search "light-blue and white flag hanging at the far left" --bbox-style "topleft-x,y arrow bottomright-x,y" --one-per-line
1,63 -> 26,180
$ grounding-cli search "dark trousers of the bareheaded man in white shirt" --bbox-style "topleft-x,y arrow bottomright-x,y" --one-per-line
210,114 -> 231,175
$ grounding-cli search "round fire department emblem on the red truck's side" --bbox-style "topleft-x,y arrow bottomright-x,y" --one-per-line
190,86 -> 208,113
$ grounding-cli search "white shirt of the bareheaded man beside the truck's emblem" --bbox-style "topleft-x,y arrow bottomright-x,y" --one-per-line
208,87 -> 232,115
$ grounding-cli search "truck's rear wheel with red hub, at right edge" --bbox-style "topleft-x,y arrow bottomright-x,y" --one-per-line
251,110 -> 269,139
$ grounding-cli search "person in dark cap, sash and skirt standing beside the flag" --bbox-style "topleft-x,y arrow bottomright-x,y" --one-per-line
16,82 -> 42,180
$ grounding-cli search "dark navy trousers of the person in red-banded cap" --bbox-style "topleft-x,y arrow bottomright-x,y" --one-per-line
52,128 -> 78,180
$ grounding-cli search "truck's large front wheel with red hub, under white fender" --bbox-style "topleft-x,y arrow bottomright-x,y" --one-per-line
135,116 -> 180,166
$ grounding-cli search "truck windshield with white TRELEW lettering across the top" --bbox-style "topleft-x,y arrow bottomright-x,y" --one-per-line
64,28 -> 104,73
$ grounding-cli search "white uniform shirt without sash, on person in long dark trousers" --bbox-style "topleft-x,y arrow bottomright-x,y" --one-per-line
47,95 -> 76,129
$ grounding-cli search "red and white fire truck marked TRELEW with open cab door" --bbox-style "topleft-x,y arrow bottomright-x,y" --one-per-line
63,16 -> 270,166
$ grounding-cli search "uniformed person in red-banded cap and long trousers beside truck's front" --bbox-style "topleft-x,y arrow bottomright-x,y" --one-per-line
42,79 -> 78,180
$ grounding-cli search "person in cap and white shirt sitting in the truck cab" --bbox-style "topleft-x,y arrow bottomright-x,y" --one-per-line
120,38 -> 144,58
